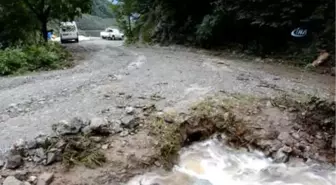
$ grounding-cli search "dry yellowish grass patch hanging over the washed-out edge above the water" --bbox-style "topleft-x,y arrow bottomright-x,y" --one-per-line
148,95 -> 253,168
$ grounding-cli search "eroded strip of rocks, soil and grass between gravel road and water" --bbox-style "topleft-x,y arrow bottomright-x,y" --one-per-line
2,93 -> 336,184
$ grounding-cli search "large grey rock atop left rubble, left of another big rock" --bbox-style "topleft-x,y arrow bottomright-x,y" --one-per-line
52,117 -> 84,135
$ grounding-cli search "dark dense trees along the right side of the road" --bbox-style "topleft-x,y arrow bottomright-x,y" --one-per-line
114,0 -> 336,65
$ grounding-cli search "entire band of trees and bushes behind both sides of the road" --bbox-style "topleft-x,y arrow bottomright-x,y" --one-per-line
0,0 -> 336,75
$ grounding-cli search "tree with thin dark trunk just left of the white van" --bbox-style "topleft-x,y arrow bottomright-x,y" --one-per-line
20,0 -> 92,41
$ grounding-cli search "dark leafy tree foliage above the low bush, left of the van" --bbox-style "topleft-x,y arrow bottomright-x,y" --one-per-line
0,0 -> 92,42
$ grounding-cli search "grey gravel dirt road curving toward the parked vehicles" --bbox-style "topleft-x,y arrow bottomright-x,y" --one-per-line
0,39 -> 336,153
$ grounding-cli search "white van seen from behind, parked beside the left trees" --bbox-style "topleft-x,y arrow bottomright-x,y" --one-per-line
60,21 -> 79,43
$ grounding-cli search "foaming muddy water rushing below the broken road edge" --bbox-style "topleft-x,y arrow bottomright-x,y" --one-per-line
128,140 -> 336,185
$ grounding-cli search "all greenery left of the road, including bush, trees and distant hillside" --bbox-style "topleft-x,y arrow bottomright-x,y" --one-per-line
0,0 -> 113,76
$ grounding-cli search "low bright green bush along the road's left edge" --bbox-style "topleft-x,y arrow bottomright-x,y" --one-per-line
0,43 -> 70,76
